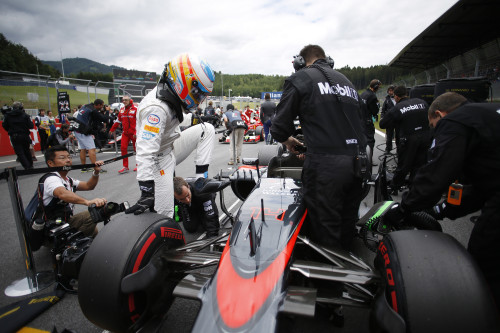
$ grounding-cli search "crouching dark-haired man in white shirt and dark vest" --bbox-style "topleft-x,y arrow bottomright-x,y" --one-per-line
41,146 -> 106,236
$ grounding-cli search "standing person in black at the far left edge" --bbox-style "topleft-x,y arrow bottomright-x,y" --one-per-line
2,102 -> 36,169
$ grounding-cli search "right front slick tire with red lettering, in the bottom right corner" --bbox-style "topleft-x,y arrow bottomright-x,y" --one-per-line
372,230 -> 500,333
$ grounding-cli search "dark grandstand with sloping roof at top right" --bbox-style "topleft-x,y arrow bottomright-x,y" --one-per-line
389,0 -> 500,101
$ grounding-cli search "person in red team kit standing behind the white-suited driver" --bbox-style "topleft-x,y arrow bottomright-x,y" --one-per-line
110,96 -> 137,173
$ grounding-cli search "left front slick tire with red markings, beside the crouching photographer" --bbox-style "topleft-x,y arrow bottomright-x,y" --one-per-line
78,213 -> 185,332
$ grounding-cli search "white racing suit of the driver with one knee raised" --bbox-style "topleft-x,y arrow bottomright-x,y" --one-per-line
136,88 -> 215,217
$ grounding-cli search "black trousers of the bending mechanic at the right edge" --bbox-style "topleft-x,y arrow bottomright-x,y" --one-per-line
468,192 -> 500,310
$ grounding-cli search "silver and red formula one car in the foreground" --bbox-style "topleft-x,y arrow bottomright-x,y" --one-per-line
79,151 -> 499,332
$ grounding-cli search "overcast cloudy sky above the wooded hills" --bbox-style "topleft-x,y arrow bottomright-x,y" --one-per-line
0,0 -> 457,75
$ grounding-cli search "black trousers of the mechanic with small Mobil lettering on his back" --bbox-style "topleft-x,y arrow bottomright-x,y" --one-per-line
392,133 -> 430,188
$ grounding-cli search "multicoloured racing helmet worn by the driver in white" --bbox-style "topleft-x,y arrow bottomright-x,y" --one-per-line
162,53 -> 215,109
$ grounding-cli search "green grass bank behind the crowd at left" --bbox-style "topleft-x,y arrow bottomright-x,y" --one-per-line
0,86 -> 108,116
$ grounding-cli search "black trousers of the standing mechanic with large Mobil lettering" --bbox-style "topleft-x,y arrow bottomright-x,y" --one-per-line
302,153 -> 361,249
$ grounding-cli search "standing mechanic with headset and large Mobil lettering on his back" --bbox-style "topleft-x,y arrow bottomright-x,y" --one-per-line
271,45 -> 366,249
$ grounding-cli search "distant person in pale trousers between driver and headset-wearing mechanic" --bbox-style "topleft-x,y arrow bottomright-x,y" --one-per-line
222,104 -> 248,165
